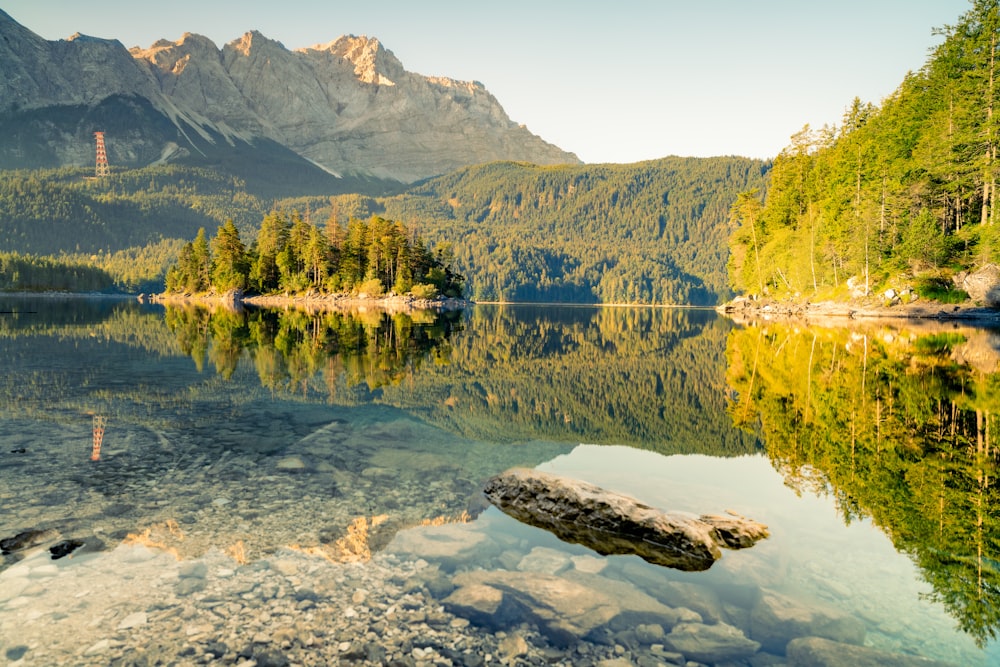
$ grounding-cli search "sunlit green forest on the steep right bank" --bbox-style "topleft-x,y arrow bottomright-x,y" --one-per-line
730,0 -> 1000,299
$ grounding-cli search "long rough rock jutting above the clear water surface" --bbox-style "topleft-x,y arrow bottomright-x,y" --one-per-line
484,468 -> 768,571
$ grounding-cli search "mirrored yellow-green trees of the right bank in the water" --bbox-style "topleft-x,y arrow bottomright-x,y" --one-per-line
727,325 -> 1000,643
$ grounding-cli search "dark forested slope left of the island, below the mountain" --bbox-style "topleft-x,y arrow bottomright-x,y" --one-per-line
0,165 -> 271,293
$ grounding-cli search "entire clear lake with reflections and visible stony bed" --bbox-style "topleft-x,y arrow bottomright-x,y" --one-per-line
0,297 -> 1000,667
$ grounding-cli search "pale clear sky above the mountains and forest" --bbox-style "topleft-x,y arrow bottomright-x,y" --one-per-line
0,0 -> 971,163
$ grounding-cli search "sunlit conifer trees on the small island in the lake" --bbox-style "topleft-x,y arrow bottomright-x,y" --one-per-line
166,212 -> 463,298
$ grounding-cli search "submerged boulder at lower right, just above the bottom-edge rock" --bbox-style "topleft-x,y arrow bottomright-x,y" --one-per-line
750,591 -> 865,655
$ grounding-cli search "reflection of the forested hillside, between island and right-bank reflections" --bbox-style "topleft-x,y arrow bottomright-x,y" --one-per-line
376,306 -> 755,456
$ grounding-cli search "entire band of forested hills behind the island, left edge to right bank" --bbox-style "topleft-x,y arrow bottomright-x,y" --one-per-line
0,158 -> 769,305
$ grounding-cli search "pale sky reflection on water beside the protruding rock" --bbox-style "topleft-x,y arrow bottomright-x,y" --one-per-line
539,445 -> 988,664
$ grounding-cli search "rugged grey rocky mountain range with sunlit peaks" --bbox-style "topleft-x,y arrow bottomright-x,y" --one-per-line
0,10 -> 579,194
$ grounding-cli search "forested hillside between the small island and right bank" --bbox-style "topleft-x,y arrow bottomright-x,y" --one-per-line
376,157 -> 768,305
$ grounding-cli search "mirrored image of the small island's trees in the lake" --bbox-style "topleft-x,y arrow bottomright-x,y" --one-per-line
166,305 -> 461,391
